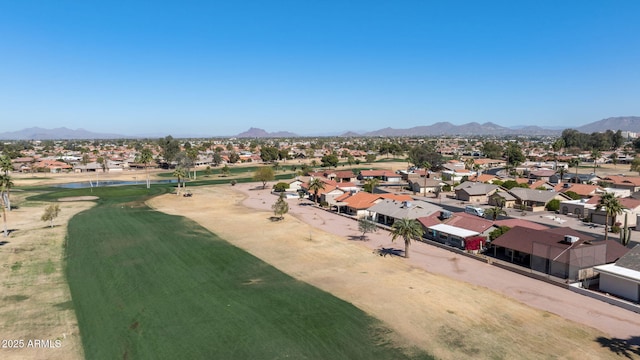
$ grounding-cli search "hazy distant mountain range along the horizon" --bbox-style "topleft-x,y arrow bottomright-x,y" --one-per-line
0,116 -> 640,140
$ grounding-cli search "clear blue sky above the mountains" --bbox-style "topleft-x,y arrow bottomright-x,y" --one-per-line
0,0 -> 640,136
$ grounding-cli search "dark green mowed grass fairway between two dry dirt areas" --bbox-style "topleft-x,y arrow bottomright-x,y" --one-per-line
67,203 -> 428,359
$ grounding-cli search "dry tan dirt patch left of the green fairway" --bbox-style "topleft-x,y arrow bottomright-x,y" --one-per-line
0,191 -> 93,360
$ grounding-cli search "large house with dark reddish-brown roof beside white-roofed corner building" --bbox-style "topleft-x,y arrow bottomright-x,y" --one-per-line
491,226 -> 629,280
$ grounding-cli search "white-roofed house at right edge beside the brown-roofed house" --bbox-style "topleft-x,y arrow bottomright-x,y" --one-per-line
595,245 -> 640,303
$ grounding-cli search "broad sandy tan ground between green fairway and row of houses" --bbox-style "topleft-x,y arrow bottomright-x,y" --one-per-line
149,184 -> 640,359
